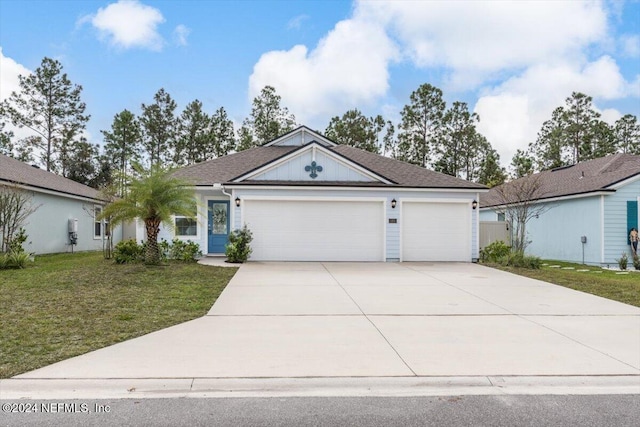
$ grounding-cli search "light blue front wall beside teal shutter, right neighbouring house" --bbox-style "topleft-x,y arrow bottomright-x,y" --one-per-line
604,178 -> 640,264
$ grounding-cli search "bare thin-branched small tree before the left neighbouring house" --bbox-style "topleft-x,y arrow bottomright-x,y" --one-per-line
0,184 -> 40,252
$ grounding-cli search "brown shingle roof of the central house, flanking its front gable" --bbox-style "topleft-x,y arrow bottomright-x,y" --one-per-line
175,145 -> 486,190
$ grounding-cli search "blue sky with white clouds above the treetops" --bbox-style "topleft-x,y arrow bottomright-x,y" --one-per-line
0,0 -> 640,164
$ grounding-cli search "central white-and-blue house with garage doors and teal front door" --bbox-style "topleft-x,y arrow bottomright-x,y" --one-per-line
159,126 -> 487,262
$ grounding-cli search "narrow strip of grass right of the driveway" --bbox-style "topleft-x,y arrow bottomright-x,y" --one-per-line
488,260 -> 640,307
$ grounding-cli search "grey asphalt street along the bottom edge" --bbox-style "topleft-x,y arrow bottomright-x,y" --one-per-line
0,395 -> 640,427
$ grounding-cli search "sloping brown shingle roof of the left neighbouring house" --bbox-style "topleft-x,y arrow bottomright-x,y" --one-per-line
0,154 -> 100,200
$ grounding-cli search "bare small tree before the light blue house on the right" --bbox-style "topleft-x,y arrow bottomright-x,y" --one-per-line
496,175 -> 552,253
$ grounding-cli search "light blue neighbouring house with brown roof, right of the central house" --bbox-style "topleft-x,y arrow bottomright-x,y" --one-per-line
480,154 -> 640,265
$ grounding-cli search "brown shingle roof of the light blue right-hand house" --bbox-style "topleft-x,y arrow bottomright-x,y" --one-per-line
480,154 -> 640,207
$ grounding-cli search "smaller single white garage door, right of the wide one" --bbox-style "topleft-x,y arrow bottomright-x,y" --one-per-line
401,202 -> 471,262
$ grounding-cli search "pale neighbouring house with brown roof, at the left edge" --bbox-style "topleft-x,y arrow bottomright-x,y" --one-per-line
0,154 -> 119,254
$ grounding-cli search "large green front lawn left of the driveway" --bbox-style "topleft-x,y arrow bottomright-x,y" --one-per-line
0,252 -> 237,378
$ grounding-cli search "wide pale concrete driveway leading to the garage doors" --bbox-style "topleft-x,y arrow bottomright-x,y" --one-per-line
17,263 -> 640,382
